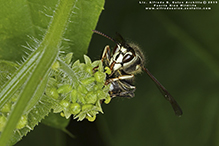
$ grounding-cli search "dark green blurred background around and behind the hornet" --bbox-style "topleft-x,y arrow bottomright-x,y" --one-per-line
17,0 -> 219,146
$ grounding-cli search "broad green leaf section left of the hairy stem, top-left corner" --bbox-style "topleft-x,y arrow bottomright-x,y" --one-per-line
0,0 -> 57,61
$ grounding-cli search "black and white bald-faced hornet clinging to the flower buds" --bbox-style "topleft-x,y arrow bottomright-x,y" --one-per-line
93,30 -> 183,116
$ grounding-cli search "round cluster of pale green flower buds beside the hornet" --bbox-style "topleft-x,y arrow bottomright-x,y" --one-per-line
45,53 -> 111,121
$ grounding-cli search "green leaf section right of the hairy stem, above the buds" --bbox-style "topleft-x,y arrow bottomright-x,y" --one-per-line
62,0 -> 104,60
